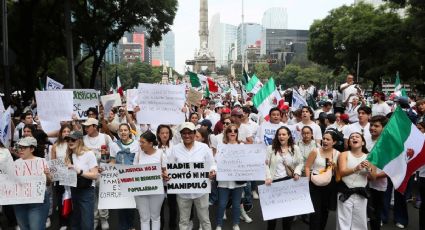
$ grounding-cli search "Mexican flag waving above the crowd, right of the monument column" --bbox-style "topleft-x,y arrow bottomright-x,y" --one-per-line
252,78 -> 282,120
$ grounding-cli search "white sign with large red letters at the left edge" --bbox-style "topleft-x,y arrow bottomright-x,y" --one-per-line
0,158 -> 47,205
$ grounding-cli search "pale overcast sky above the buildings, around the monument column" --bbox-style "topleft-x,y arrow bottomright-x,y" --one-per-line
171,0 -> 354,73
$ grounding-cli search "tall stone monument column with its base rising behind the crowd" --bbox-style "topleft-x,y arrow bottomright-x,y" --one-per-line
186,0 -> 216,76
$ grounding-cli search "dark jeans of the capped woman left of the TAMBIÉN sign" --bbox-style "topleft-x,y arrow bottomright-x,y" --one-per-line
71,187 -> 95,230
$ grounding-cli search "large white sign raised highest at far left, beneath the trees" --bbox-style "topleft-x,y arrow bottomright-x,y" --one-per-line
35,90 -> 74,133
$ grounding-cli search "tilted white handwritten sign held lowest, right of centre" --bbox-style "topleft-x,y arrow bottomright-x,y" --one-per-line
258,177 -> 314,220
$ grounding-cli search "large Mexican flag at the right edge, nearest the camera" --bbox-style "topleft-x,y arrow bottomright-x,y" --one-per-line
367,107 -> 425,193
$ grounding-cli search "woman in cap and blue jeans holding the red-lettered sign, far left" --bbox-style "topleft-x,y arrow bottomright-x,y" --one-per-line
14,137 -> 52,230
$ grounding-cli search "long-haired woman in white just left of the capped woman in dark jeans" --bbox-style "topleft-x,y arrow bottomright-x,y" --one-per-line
50,124 -> 72,230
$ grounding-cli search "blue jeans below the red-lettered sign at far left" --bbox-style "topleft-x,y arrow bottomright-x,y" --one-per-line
13,190 -> 50,230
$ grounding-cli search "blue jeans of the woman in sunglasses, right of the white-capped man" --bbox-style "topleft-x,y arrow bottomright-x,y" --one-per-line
217,187 -> 244,227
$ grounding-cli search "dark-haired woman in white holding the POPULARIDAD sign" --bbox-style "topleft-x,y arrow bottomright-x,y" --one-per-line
134,131 -> 167,230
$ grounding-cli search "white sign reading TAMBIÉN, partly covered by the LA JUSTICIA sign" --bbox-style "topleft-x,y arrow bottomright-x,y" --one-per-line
98,164 -> 136,209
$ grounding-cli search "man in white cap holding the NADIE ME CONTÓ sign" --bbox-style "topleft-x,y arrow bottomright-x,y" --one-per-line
169,122 -> 216,230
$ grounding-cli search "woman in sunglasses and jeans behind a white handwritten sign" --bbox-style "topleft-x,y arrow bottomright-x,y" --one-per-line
216,124 -> 246,230
